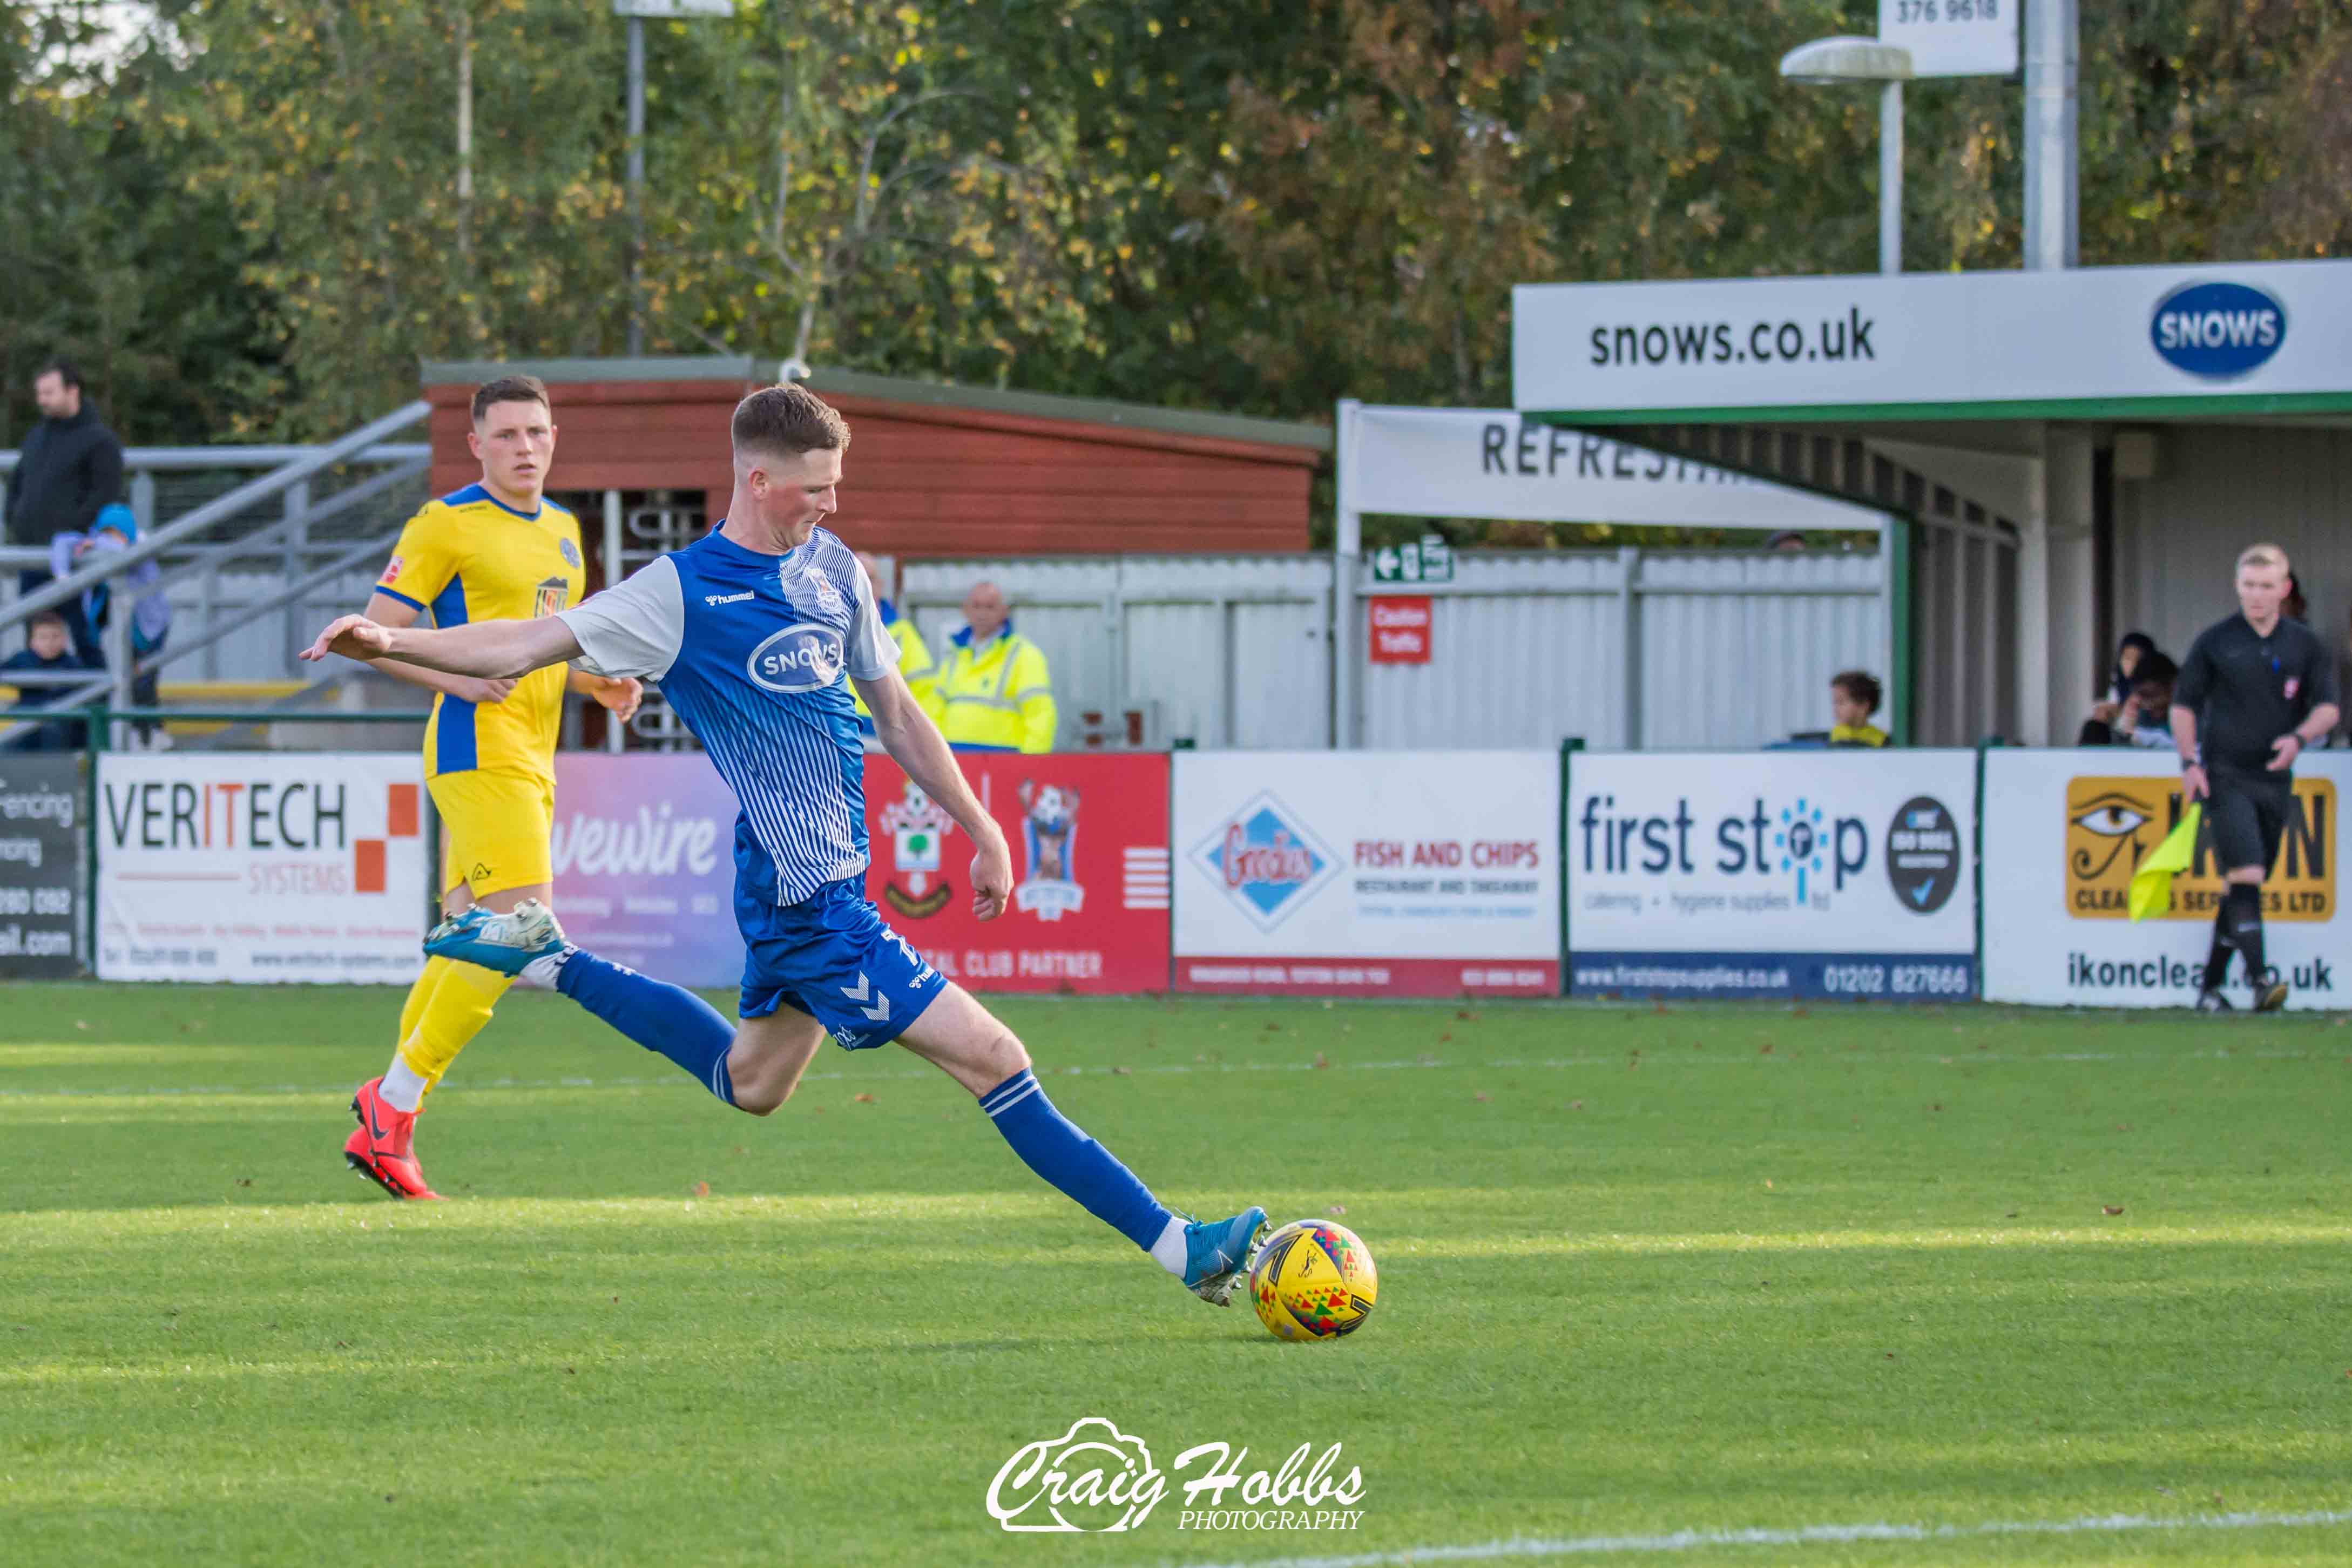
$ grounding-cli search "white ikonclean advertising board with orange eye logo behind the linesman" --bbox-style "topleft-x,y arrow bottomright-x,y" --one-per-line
1985,748 -> 2352,1009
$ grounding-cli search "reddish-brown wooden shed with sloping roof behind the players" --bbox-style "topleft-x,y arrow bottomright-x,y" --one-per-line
423,357 -> 1331,559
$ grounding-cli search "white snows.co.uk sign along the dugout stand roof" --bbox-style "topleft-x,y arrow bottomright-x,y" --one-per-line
1512,261 -> 2352,421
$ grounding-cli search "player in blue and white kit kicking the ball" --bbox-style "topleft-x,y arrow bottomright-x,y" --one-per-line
303,386 -> 1266,1307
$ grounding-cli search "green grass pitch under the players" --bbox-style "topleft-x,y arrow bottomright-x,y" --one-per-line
0,985 -> 2352,1568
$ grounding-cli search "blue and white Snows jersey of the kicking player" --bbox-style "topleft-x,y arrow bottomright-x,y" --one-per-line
562,529 -> 898,905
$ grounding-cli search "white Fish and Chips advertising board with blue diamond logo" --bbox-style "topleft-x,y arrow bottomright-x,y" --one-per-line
1174,752 -> 1559,997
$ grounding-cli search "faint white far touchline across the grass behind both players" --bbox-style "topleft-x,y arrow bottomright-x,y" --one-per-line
0,1049 -> 2333,1100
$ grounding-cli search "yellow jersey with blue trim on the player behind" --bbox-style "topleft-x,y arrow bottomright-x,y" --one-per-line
376,484 -> 586,785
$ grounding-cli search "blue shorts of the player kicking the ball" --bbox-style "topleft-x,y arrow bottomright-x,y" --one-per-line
736,877 -> 948,1051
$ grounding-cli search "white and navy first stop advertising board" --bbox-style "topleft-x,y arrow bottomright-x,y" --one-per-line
1564,750 -> 1976,1002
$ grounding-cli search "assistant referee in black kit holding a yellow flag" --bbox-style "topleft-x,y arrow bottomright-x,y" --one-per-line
2173,545 -> 2338,1013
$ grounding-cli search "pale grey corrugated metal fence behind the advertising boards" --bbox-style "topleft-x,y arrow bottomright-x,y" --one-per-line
903,550 -> 1894,748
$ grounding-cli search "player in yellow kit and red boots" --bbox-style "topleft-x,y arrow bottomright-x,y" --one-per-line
343,376 -> 645,1199
